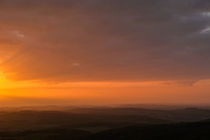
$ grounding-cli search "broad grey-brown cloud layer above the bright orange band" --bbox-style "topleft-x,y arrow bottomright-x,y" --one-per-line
0,0 -> 210,81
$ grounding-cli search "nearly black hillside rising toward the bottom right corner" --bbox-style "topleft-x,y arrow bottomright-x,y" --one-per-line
89,122 -> 210,140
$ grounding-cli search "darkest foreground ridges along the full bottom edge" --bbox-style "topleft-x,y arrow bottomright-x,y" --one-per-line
0,122 -> 210,140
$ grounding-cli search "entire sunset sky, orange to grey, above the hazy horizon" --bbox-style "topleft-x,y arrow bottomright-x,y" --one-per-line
0,0 -> 210,106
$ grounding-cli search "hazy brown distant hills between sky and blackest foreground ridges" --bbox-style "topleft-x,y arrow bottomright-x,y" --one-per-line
0,107 -> 210,132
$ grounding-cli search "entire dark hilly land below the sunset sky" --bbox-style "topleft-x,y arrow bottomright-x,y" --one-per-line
0,108 -> 210,140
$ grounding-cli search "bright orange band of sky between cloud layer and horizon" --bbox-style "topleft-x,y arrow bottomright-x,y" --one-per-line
0,72 -> 210,105
